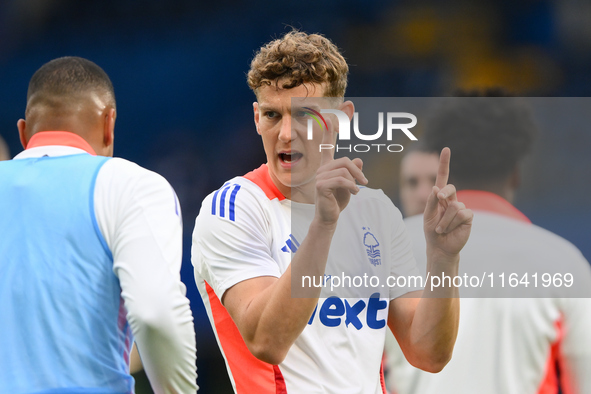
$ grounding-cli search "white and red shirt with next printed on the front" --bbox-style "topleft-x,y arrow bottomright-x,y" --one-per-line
192,165 -> 418,394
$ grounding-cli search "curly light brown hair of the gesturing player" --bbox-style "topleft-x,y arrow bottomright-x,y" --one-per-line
247,30 -> 349,97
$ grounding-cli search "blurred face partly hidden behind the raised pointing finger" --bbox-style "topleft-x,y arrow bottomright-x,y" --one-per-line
400,142 -> 439,217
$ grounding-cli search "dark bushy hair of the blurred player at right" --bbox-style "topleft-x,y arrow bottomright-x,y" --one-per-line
423,89 -> 537,189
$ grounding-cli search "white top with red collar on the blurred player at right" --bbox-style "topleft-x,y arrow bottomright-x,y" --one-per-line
386,191 -> 591,394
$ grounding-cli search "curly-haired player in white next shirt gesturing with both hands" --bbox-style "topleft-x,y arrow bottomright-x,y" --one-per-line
192,32 -> 472,394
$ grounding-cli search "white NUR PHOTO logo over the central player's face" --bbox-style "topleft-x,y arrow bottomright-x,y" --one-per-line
302,107 -> 417,153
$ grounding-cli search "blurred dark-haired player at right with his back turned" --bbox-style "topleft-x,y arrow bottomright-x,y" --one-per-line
387,91 -> 591,394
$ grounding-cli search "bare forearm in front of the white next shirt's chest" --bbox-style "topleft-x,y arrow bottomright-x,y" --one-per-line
247,222 -> 336,364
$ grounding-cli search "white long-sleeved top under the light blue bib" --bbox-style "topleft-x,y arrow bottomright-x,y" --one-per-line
14,136 -> 197,393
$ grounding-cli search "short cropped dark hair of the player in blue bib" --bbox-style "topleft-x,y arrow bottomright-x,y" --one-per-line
27,56 -> 115,106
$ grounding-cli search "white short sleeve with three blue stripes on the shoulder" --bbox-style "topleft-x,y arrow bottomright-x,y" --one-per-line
191,183 -> 281,300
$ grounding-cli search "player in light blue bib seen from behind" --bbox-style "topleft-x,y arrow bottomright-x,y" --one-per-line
0,57 -> 197,394
